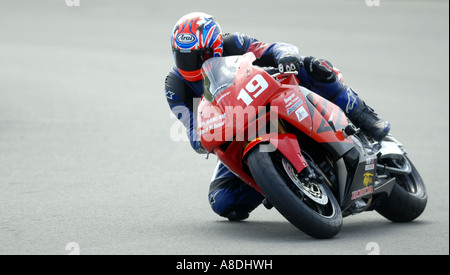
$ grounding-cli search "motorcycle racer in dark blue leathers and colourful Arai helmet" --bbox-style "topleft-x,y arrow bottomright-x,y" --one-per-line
165,12 -> 390,221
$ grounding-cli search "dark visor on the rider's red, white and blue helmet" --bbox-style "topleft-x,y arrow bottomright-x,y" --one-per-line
173,48 -> 213,72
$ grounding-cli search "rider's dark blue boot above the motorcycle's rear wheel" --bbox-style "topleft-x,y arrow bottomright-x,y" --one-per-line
333,86 -> 391,141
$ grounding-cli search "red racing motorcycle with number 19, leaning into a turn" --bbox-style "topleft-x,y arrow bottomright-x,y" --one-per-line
197,53 -> 427,238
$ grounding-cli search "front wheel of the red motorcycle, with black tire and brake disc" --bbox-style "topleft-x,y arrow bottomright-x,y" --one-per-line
247,147 -> 342,239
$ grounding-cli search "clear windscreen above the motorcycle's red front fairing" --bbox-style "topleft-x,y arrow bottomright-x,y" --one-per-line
202,56 -> 242,103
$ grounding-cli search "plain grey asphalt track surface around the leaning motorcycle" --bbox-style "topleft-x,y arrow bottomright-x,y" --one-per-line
0,0 -> 449,255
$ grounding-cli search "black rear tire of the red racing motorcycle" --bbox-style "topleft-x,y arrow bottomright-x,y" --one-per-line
376,157 -> 428,222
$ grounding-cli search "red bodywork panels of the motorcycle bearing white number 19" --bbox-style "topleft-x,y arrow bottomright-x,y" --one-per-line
197,53 -> 352,192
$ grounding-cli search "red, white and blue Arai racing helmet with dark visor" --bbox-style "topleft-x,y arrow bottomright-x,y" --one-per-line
171,12 -> 223,82
